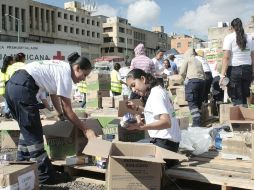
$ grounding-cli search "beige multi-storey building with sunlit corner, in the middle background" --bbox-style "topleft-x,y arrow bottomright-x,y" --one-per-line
101,17 -> 168,58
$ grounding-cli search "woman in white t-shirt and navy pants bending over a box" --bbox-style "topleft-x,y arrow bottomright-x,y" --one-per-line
6,53 -> 95,184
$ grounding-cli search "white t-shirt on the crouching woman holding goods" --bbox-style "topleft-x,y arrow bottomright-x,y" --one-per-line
144,86 -> 181,142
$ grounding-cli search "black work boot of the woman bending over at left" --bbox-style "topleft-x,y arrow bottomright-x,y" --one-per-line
42,172 -> 72,185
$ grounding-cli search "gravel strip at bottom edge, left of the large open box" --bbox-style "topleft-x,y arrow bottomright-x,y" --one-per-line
40,181 -> 105,190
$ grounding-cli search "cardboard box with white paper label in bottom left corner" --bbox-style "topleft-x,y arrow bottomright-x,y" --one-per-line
0,162 -> 39,190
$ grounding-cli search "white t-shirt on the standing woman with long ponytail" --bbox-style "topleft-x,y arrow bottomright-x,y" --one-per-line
223,32 -> 254,66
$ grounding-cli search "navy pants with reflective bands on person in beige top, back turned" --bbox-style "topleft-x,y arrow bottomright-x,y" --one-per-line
185,79 -> 205,127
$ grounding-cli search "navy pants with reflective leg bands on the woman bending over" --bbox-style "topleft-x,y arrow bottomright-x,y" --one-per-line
6,70 -> 54,183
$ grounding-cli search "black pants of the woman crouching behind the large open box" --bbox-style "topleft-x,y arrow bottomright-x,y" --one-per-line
150,138 -> 179,168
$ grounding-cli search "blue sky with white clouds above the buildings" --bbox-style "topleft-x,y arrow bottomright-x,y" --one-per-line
38,0 -> 254,38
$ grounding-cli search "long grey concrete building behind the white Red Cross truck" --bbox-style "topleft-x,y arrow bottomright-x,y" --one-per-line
0,0 -> 102,59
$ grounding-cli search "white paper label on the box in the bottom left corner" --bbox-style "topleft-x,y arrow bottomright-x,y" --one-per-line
18,170 -> 35,190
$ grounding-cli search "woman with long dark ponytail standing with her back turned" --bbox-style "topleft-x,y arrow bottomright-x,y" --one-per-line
220,18 -> 254,106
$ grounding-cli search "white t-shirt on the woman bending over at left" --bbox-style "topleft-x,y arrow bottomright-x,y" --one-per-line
24,60 -> 72,98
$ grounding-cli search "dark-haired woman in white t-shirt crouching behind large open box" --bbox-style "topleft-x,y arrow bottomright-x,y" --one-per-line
126,69 -> 181,167
